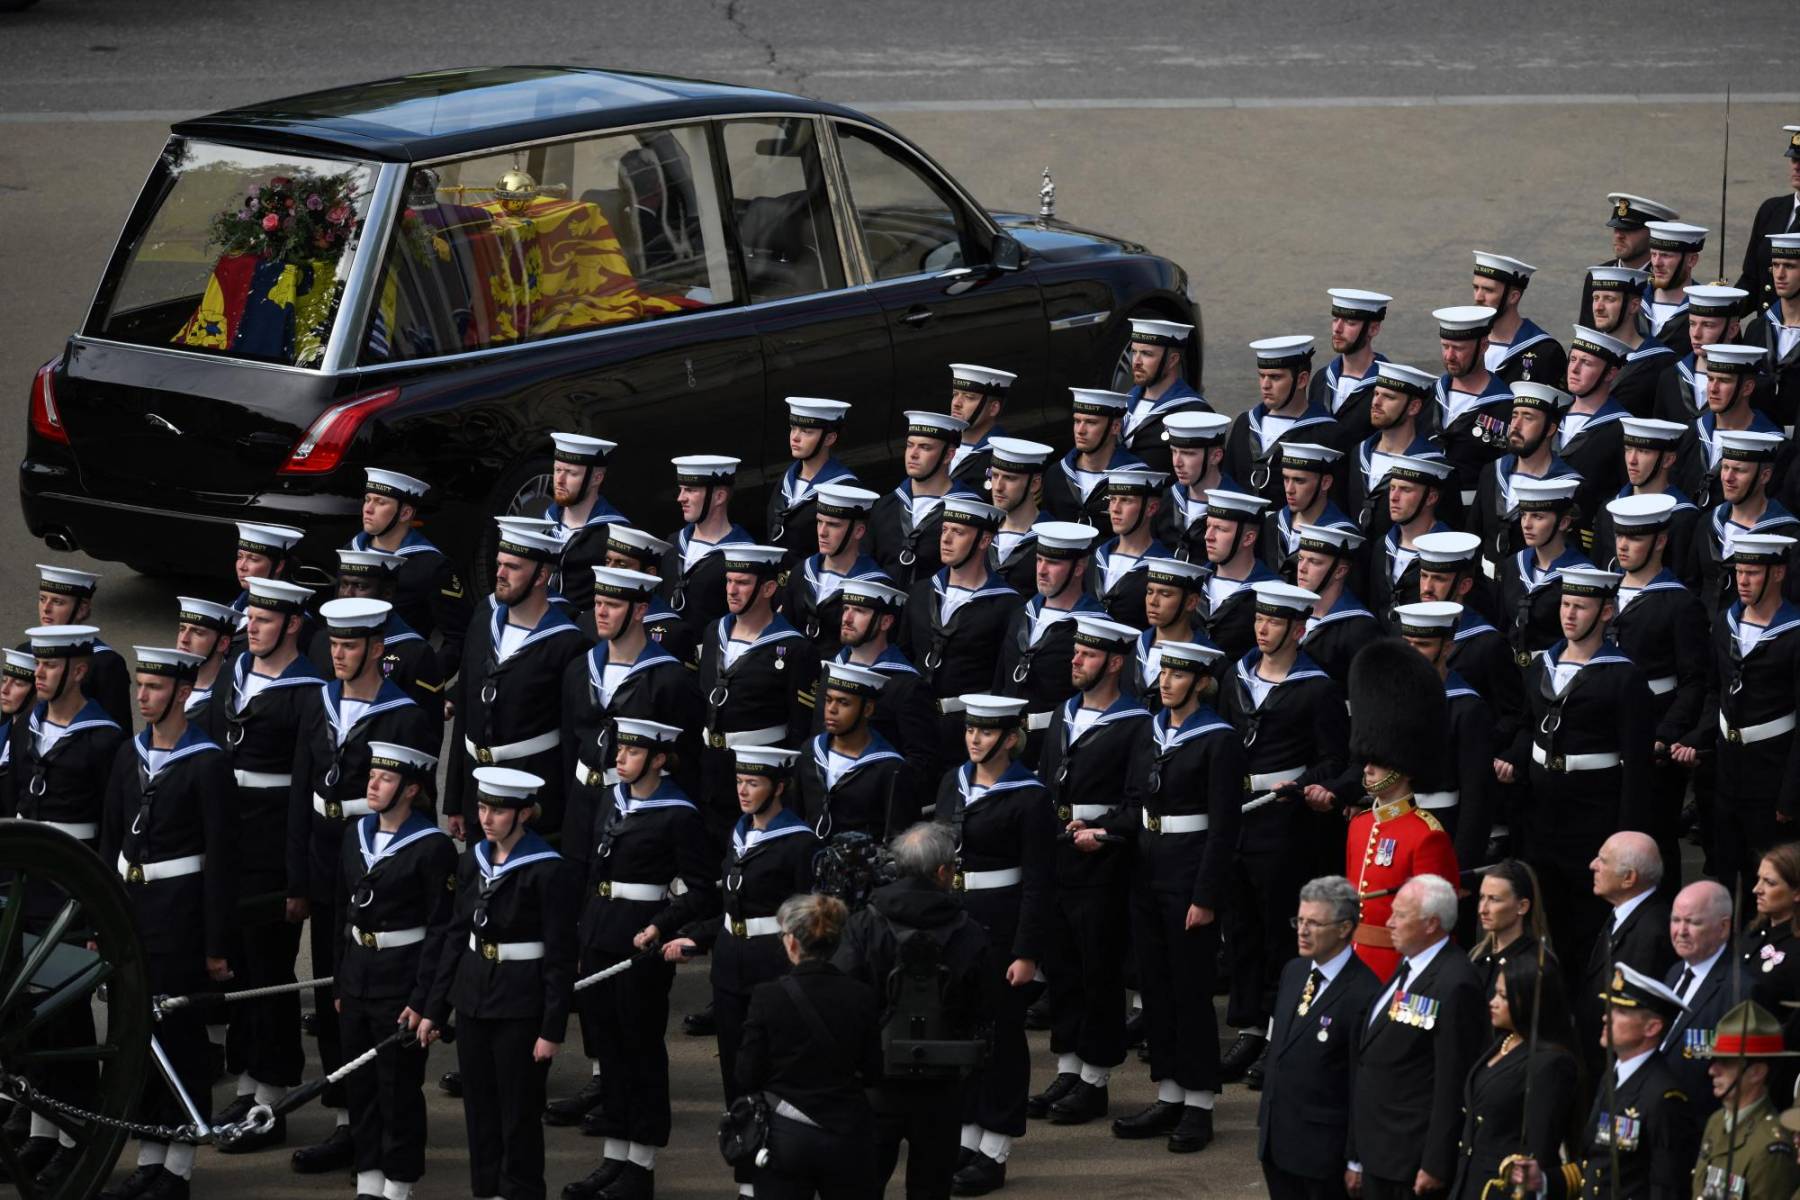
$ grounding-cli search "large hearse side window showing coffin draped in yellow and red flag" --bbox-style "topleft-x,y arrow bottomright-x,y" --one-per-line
364,126 -> 734,363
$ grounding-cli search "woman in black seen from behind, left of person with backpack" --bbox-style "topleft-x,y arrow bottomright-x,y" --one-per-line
736,896 -> 882,1200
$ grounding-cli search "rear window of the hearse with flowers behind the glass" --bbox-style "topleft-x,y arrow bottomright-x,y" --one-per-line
88,139 -> 374,367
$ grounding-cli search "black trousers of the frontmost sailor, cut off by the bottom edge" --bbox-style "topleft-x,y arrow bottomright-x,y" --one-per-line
455,1016 -> 551,1200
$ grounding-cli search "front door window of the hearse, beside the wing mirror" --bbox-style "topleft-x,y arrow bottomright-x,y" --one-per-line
837,124 -> 965,279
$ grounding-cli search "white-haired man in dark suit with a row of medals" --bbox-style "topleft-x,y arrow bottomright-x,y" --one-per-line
1345,874 -> 1489,1200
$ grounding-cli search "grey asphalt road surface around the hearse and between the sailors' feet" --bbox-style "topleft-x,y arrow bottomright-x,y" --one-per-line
0,0 -> 1800,1200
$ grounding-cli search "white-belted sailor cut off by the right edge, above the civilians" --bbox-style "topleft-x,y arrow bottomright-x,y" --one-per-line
1670,525 -> 1800,899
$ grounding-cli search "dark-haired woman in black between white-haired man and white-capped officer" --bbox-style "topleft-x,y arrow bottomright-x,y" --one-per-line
1449,954 -> 1579,1200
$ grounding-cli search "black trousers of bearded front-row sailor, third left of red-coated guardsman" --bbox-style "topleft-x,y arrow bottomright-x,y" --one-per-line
1044,880 -> 1127,1067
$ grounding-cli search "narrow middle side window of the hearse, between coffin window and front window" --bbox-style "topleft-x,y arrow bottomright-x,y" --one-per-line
724,117 -> 844,302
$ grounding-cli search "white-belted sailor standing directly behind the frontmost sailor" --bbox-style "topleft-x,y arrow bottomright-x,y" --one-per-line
445,518 -> 587,840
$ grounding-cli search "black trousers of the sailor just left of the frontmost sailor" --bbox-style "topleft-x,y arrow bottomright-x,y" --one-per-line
338,997 -> 428,1184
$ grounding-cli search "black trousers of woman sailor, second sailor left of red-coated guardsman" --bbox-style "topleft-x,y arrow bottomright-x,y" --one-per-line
1130,887 -> 1219,1092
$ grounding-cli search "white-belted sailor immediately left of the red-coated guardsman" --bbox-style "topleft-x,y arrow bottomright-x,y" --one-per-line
1219,581 -> 1348,1083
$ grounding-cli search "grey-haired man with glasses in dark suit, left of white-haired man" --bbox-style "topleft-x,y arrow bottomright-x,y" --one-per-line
1256,874 -> 1381,1200
